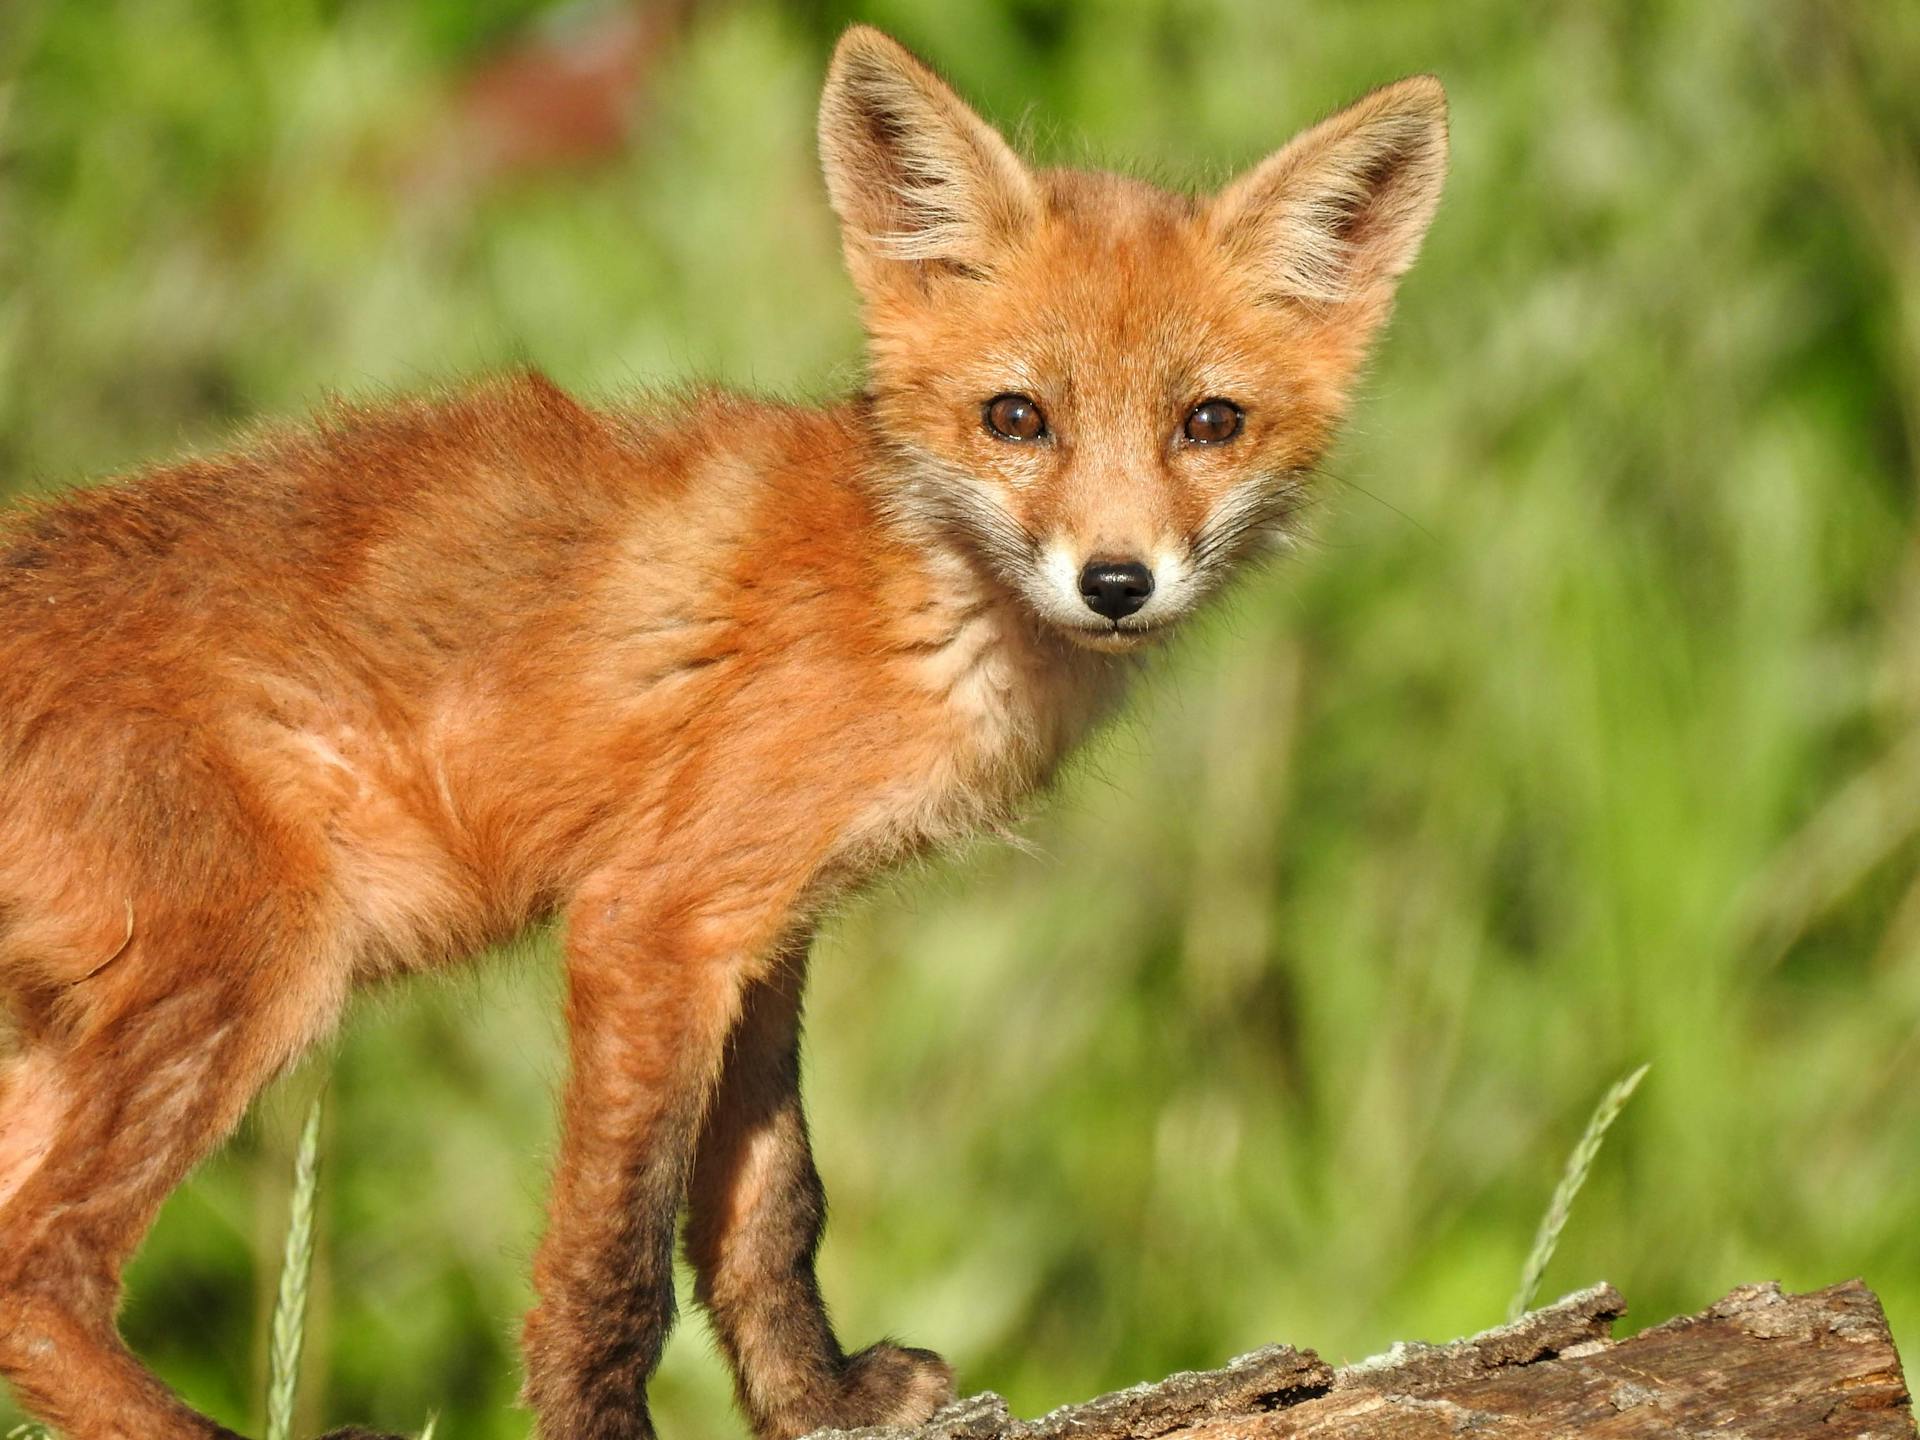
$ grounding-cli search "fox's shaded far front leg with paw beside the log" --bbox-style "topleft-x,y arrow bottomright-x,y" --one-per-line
687,939 -> 954,1440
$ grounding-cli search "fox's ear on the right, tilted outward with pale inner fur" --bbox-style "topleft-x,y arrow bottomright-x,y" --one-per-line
1208,75 -> 1446,303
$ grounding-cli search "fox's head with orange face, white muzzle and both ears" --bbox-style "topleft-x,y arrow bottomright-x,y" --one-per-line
820,25 -> 1448,649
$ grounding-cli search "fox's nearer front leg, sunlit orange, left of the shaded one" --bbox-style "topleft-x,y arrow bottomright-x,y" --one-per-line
524,876 -> 781,1440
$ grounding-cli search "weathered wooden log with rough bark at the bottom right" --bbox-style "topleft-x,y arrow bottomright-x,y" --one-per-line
817,1281 -> 1916,1440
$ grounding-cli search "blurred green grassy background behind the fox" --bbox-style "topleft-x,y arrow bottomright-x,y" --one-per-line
0,0 -> 1920,1440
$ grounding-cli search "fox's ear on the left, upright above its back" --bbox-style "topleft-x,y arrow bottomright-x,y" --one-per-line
820,25 -> 1041,292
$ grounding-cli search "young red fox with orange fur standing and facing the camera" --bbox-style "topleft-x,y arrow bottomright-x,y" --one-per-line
0,27 -> 1448,1440
